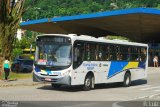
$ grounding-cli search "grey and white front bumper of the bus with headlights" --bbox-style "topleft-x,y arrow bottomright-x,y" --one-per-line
33,72 -> 71,85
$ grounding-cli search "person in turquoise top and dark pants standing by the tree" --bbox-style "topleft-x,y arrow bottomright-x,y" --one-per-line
3,57 -> 10,80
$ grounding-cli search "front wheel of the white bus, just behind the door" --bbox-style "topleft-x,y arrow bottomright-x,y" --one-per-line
83,75 -> 92,91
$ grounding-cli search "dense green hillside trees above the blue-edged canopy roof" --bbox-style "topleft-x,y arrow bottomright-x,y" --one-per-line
23,0 -> 160,20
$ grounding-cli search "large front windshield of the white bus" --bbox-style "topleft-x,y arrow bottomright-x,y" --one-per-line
35,42 -> 71,70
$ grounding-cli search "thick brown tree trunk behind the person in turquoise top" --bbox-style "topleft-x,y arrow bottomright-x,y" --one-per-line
0,0 -> 25,58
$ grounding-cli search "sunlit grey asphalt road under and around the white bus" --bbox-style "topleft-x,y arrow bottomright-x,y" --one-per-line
0,68 -> 160,107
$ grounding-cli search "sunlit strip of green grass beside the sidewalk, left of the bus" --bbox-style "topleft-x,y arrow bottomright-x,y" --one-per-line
2,72 -> 32,80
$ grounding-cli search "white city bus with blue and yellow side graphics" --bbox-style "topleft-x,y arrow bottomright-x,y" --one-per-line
33,34 -> 148,90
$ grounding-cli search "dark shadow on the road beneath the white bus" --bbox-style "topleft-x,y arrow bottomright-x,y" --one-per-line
37,80 -> 147,92
